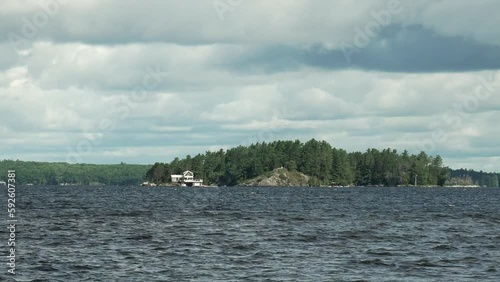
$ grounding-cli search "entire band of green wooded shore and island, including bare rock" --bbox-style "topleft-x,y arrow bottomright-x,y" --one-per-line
0,139 -> 500,187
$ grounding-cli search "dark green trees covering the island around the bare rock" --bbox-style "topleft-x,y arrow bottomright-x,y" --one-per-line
146,139 -> 498,187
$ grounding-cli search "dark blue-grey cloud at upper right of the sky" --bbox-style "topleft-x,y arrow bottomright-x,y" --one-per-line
225,25 -> 500,73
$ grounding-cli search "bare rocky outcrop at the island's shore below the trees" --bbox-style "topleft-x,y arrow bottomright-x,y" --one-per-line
238,168 -> 309,187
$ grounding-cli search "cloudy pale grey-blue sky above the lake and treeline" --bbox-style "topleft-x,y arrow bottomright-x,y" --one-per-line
0,0 -> 500,172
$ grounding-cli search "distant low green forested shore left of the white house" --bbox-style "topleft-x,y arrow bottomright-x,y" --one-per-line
0,160 -> 148,185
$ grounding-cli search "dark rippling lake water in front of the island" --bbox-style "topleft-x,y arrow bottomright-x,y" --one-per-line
0,187 -> 500,281
